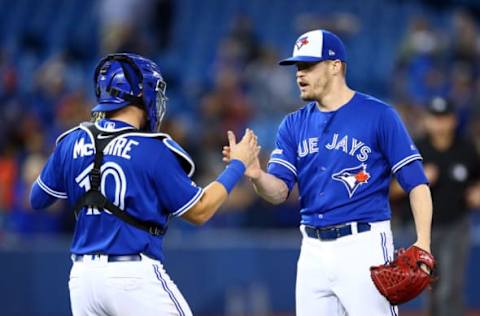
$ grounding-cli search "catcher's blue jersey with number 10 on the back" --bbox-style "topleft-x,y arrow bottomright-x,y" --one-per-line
31,120 -> 203,260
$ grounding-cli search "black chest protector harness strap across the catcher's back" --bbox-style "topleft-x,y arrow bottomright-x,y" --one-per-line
74,124 -> 167,236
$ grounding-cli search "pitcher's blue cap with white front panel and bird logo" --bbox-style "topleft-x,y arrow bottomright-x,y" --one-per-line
278,30 -> 346,66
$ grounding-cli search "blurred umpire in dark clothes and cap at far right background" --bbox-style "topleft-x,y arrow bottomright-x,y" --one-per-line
417,97 -> 480,316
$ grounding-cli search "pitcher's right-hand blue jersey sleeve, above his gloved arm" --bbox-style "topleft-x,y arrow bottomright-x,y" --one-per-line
379,107 -> 422,173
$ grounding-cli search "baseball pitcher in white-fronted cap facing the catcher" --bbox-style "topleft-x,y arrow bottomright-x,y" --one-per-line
224,30 -> 433,316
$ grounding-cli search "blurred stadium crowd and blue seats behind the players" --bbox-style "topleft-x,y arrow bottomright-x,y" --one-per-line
0,0 -> 480,314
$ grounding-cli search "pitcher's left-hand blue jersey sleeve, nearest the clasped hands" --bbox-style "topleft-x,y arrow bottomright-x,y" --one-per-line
267,117 -> 297,191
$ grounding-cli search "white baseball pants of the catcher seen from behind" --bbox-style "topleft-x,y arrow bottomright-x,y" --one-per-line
69,255 -> 192,316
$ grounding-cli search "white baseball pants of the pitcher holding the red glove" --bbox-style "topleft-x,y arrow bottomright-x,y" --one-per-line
296,221 -> 398,316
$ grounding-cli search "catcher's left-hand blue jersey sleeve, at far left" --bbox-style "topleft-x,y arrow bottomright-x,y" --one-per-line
33,144 -> 68,199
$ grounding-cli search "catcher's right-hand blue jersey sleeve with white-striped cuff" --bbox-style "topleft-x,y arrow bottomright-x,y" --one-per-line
154,147 -> 203,216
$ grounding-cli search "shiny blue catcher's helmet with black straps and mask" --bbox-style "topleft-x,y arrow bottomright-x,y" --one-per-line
92,53 -> 167,132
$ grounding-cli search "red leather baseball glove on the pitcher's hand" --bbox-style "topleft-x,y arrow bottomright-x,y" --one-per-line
370,246 -> 435,305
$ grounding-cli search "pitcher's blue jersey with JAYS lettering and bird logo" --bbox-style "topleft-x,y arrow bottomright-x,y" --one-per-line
268,92 -> 422,227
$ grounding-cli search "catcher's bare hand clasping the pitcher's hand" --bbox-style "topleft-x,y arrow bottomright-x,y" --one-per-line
222,128 -> 260,176
